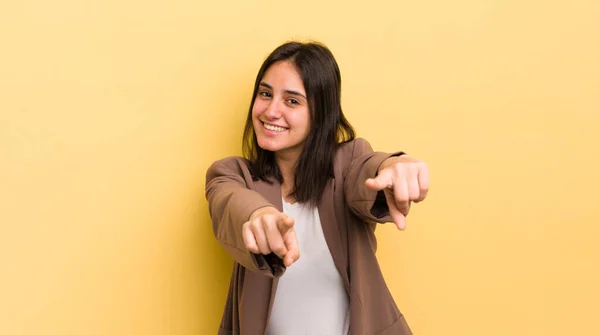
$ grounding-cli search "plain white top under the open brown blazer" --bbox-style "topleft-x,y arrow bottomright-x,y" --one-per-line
267,200 -> 350,335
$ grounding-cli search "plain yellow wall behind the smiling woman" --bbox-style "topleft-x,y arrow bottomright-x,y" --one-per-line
0,0 -> 600,335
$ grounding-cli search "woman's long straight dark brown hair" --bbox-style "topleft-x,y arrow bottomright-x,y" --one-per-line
242,42 -> 355,206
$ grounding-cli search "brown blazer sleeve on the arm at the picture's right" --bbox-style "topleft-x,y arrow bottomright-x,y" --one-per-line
344,138 -> 404,223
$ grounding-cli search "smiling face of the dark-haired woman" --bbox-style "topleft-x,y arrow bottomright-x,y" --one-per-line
252,61 -> 310,159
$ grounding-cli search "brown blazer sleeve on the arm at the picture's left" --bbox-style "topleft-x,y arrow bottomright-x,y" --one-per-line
206,157 -> 285,278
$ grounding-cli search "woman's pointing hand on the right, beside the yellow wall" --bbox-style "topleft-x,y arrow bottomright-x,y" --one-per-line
365,155 -> 429,230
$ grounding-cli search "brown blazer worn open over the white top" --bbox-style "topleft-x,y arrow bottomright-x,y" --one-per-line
206,138 -> 412,335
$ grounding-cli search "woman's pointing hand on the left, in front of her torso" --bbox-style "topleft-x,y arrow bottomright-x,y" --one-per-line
242,207 -> 300,266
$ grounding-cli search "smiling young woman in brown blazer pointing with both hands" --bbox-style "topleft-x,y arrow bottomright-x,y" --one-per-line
206,42 -> 429,335
